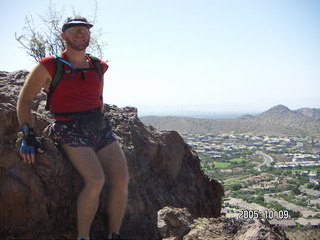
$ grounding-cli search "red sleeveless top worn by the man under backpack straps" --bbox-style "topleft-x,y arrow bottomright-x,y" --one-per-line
40,52 -> 108,120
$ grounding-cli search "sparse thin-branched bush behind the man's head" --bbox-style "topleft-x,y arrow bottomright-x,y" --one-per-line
15,1 -> 105,62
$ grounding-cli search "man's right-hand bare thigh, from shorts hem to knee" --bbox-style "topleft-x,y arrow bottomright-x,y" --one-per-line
97,141 -> 128,184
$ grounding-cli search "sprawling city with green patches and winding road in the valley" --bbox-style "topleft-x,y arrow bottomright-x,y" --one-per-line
182,133 -> 320,229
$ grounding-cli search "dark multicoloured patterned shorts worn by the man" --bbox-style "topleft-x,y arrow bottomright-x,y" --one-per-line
50,122 -> 117,152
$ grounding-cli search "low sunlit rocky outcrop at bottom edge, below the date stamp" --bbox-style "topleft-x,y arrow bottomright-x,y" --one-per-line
158,207 -> 287,240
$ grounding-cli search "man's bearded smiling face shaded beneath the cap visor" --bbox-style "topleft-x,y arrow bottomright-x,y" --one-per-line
61,26 -> 90,51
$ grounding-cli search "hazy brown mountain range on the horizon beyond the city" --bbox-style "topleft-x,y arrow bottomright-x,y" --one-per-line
141,105 -> 320,137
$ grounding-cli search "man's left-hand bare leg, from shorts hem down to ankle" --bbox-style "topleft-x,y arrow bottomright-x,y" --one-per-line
62,144 -> 105,238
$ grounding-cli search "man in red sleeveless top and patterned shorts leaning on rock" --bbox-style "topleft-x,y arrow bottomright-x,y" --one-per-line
17,16 -> 129,240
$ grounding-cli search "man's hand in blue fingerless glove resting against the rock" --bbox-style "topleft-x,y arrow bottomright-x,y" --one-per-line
19,134 -> 43,164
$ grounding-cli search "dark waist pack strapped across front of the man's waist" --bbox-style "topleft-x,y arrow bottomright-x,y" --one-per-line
73,112 -> 107,132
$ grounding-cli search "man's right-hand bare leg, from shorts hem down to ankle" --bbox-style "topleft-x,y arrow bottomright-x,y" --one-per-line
97,141 -> 129,234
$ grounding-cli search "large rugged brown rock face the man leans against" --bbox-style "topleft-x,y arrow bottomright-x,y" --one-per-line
0,71 -> 224,239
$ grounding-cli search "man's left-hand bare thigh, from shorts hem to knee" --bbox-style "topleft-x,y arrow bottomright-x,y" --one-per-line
62,144 -> 104,181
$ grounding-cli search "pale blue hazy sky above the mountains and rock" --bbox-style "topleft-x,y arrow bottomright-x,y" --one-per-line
0,0 -> 320,111
